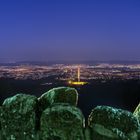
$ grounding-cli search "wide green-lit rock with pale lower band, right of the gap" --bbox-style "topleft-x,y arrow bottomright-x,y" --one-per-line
88,106 -> 140,140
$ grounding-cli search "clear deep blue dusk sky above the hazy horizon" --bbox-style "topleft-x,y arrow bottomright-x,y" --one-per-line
0,0 -> 140,62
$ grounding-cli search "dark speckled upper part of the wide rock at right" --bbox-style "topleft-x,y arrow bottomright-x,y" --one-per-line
89,106 -> 139,133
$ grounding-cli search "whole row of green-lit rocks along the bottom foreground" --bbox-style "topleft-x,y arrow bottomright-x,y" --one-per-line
0,87 -> 140,140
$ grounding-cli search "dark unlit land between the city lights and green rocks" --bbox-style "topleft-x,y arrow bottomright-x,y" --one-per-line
0,77 -> 140,118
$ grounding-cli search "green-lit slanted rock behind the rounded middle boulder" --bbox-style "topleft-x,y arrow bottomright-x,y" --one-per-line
38,87 -> 78,111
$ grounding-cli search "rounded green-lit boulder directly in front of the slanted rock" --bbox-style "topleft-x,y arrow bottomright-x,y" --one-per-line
41,104 -> 85,140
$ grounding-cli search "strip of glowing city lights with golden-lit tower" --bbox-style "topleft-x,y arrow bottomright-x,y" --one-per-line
0,64 -> 140,81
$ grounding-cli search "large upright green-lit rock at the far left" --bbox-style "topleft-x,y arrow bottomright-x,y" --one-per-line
1,94 -> 37,140
